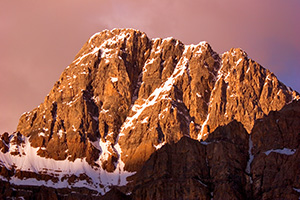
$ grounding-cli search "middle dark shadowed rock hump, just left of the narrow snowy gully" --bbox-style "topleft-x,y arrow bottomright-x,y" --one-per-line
205,121 -> 249,199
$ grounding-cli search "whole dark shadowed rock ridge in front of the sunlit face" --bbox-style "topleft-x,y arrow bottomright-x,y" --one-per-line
131,102 -> 300,199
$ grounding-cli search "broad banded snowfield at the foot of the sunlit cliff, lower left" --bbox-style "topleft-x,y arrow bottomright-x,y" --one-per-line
0,137 -> 134,194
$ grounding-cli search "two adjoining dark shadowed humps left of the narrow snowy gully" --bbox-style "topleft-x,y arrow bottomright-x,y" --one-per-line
131,121 -> 249,199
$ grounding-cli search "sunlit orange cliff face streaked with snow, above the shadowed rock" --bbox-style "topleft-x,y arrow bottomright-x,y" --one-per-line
0,29 -> 299,198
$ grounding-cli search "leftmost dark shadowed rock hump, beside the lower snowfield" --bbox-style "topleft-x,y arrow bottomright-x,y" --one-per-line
132,137 -> 210,199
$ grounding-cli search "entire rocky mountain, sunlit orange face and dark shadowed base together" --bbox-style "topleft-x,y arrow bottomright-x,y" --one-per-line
0,29 -> 300,199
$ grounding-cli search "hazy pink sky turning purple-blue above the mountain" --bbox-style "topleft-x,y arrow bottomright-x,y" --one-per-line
0,0 -> 300,133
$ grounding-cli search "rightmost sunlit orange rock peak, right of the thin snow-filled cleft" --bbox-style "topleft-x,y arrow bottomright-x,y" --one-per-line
207,49 -> 299,133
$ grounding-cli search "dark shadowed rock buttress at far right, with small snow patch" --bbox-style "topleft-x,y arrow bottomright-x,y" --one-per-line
251,101 -> 300,199
